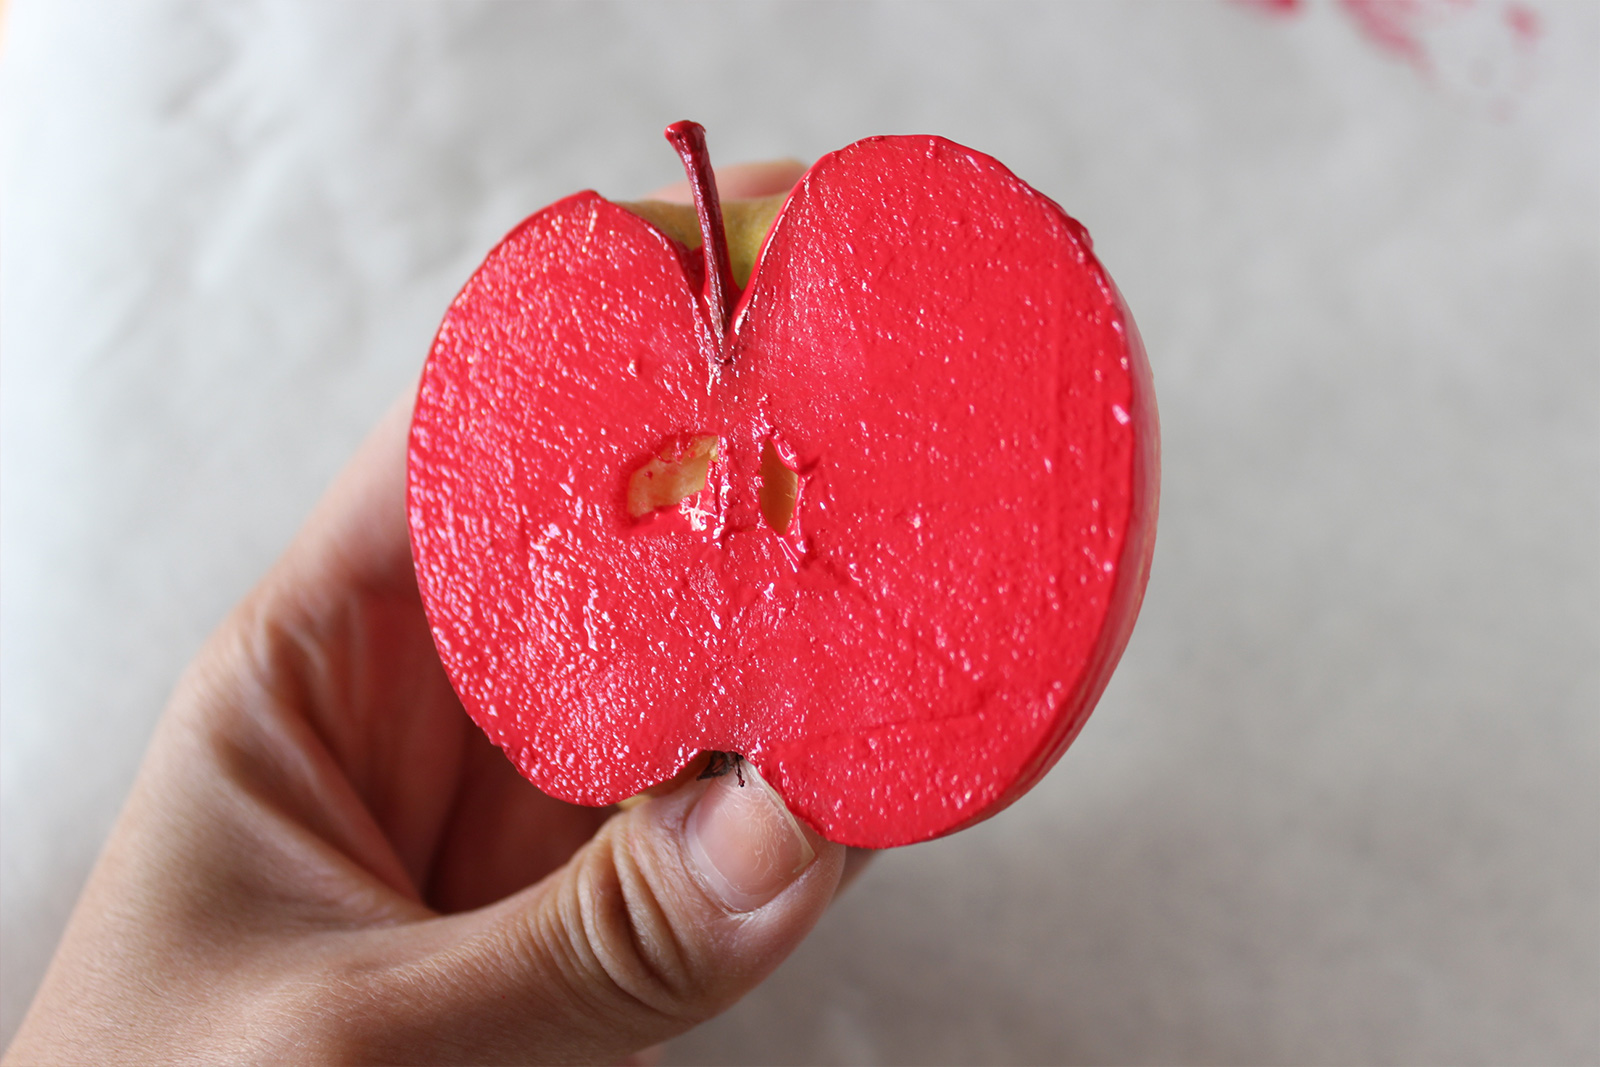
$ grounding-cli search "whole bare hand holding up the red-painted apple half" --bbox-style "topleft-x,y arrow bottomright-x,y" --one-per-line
5,163 -> 866,1064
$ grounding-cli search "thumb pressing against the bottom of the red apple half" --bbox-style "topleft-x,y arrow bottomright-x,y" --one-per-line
352,763 -> 845,1062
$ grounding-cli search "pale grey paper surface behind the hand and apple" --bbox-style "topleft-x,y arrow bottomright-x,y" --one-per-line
0,0 -> 1600,1062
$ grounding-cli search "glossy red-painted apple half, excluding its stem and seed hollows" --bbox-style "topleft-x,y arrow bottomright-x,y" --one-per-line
408,136 -> 1160,848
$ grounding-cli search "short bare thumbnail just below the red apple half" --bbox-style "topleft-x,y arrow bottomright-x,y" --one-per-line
688,763 -> 816,912
